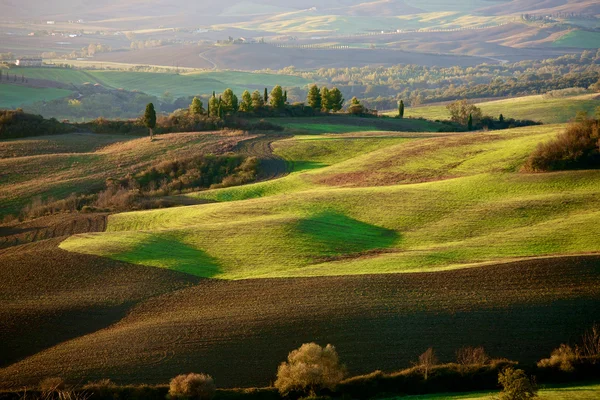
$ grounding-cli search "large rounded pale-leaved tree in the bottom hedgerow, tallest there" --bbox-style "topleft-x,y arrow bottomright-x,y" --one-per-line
275,343 -> 346,396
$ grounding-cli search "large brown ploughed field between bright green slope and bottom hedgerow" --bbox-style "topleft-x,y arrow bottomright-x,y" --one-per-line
0,256 -> 600,387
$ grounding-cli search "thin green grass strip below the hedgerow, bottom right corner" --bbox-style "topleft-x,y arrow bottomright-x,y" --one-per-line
392,385 -> 600,400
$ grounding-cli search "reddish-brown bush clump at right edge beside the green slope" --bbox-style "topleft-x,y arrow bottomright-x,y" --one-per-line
523,117 -> 600,172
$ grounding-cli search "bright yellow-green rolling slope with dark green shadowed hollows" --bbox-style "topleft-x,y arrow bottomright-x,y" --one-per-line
61,125 -> 600,279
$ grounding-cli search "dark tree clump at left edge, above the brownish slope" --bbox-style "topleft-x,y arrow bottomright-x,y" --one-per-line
0,110 -> 75,139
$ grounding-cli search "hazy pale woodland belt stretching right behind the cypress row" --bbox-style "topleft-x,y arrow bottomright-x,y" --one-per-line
260,50 -> 600,110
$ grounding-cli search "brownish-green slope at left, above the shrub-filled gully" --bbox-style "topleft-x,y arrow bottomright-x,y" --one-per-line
0,133 -> 252,216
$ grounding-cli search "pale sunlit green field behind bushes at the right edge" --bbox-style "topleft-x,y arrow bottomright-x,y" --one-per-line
400,94 -> 600,124
